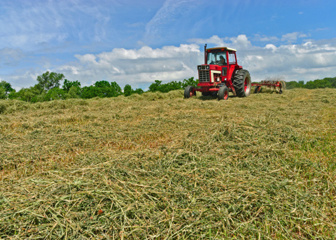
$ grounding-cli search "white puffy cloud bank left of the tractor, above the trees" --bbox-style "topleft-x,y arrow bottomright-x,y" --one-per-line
58,44 -> 202,87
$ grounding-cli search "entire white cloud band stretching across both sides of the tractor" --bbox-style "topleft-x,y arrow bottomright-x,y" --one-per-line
7,35 -> 336,88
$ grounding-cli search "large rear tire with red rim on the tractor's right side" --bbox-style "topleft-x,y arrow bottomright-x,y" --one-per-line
232,69 -> 251,97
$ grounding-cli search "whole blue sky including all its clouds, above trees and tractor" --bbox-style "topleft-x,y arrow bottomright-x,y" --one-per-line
0,0 -> 336,89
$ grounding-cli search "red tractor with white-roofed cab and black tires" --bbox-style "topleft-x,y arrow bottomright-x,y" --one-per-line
184,45 -> 251,100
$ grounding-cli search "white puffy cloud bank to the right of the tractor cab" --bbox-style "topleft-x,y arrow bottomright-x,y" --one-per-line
186,32 -> 336,81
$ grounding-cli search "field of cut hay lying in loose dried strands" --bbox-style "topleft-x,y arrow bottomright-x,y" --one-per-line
0,89 -> 336,239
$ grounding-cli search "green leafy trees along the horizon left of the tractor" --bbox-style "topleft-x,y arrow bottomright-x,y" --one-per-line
0,71 -> 198,103
